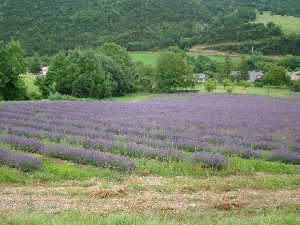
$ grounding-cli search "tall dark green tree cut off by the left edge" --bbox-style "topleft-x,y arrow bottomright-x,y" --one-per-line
0,41 -> 27,100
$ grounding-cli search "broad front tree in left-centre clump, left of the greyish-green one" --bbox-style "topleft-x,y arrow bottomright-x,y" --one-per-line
40,50 -> 111,99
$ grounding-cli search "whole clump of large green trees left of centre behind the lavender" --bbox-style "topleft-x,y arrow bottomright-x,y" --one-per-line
36,44 -> 137,99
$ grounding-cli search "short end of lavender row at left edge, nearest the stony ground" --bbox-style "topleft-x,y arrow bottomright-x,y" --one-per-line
0,148 -> 41,172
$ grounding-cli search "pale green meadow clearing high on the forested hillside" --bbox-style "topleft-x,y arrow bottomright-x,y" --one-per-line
255,11 -> 300,34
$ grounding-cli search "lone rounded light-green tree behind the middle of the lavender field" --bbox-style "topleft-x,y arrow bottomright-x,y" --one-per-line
155,51 -> 197,92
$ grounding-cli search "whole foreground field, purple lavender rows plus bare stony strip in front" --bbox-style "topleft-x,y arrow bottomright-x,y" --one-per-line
0,94 -> 300,224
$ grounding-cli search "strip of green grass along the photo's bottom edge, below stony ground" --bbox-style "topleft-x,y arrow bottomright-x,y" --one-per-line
0,211 -> 300,225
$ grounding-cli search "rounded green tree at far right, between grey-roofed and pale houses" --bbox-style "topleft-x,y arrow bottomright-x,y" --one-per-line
262,65 -> 291,87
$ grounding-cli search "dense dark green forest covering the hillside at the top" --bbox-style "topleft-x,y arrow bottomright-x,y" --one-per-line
0,0 -> 300,55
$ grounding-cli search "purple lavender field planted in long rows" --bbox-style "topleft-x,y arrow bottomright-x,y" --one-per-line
0,94 -> 300,173
